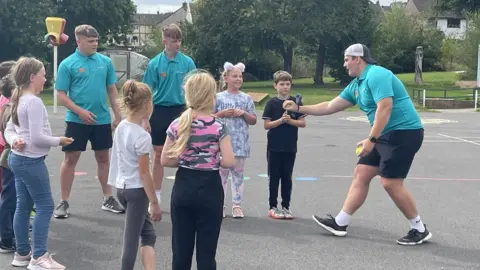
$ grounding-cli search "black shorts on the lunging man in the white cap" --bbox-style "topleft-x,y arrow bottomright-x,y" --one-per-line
358,129 -> 424,179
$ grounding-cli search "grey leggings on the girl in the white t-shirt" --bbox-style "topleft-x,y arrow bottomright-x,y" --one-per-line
117,188 -> 157,270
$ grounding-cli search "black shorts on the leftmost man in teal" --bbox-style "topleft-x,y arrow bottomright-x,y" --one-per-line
62,122 -> 113,152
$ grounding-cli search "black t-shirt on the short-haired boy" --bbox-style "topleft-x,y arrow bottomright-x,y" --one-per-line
262,97 -> 305,152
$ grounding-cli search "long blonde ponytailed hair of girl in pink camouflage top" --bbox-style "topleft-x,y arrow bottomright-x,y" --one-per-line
169,70 -> 217,158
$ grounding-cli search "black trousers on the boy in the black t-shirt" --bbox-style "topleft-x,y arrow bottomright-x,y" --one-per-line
267,151 -> 296,209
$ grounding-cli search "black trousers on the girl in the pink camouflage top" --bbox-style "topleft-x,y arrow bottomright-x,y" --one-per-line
170,167 -> 224,270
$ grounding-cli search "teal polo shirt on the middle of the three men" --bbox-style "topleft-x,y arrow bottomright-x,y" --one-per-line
143,51 -> 196,106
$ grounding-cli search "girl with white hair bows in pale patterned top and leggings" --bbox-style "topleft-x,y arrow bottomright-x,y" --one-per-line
215,62 -> 257,218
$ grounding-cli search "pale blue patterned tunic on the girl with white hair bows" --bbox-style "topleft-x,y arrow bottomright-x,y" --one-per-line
215,90 -> 255,157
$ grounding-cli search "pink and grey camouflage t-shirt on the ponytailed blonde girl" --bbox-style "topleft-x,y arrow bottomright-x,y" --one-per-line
167,116 -> 228,171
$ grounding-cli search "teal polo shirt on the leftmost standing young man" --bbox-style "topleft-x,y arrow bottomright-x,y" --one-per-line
55,49 -> 117,125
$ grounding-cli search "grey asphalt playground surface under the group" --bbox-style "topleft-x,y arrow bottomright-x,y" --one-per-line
0,107 -> 480,270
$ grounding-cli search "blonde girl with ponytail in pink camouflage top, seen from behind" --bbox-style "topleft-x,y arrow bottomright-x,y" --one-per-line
161,71 -> 234,270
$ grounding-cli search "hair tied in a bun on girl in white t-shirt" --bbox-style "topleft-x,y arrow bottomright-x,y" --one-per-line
119,80 -> 152,114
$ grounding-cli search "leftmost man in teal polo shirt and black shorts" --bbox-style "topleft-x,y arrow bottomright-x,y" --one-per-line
54,25 -> 124,218
